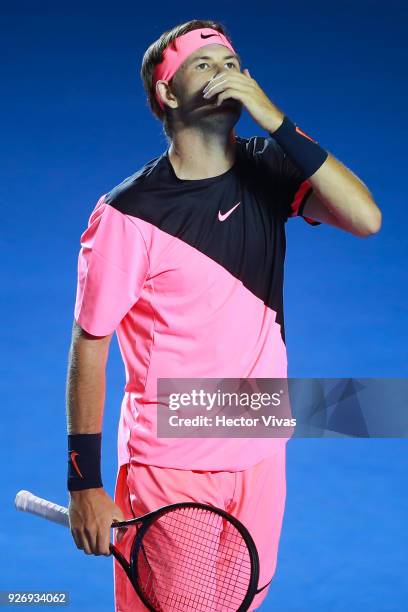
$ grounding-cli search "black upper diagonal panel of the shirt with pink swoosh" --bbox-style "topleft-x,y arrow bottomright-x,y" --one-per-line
106,137 -> 312,341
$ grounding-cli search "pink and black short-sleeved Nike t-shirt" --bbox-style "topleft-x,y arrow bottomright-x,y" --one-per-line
75,137 -> 319,471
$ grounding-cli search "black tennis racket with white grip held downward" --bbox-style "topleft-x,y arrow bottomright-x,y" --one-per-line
15,491 -> 263,612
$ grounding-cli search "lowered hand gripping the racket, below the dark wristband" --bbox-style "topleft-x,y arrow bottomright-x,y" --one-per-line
68,487 -> 126,556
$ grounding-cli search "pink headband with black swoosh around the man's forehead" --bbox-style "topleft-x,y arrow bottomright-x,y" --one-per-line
153,28 -> 235,108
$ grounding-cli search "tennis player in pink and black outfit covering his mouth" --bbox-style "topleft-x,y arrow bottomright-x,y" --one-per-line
67,20 -> 381,612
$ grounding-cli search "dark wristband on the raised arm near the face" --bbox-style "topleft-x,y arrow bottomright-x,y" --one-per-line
269,115 -> 329,180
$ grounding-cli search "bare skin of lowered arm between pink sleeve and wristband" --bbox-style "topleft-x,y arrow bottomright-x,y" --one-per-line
66,323 -> 111,434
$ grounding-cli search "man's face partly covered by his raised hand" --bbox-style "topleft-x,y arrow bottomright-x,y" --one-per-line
168,44 -> 242,128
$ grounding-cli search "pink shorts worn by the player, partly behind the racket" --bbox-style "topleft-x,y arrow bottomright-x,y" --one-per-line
113,447 -> 286,612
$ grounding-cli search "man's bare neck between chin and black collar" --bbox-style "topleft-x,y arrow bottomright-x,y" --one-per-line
168,126 -> 235,180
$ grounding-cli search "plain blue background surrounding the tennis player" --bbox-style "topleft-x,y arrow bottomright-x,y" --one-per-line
0,0 -> 408,612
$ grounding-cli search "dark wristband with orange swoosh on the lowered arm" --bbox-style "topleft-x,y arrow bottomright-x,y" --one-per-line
67,433 -> 103,491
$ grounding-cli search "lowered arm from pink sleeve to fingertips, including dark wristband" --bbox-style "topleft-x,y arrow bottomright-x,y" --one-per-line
66,322 -> 125,556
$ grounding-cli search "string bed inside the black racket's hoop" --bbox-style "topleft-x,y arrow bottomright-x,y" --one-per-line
135,508 -> 252,612
